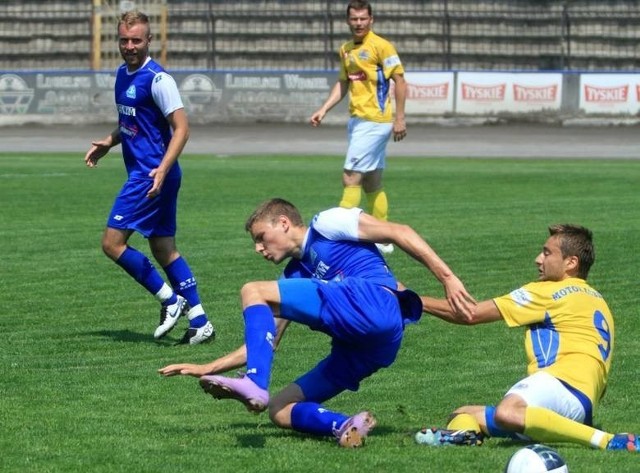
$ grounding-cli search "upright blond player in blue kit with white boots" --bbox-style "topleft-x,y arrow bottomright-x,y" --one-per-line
84,11 -> 215,345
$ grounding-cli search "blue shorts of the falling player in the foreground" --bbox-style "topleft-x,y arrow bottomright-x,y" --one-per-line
278,278 -> 403,402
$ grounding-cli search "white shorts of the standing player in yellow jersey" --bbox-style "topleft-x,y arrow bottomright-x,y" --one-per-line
344,117 -> 393,173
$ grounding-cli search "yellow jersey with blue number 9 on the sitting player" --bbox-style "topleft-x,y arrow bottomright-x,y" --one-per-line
493,278 -> 614,406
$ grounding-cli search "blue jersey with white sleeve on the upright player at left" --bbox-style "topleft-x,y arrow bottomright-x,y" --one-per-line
115,58 -> 183,179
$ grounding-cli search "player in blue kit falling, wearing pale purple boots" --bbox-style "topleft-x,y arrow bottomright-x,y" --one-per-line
159,199 -> 474,447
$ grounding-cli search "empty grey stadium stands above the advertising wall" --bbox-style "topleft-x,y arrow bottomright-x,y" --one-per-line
0,0 -> 640,71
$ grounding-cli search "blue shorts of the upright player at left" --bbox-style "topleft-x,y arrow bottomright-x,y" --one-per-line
107,179 -> 181,238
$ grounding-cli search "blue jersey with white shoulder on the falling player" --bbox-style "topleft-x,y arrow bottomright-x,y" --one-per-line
284,207 -> 398,290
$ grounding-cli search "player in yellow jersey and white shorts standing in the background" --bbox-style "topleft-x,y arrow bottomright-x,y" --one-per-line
311,0 -> 407,253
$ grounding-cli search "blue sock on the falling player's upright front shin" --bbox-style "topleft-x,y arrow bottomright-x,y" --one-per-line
242,304 -> 276,389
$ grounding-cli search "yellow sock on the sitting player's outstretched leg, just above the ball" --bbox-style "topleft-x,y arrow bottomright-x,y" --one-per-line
524,407 -> 613,450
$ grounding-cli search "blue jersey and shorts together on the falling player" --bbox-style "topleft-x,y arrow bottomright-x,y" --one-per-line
278,207 -> 422,396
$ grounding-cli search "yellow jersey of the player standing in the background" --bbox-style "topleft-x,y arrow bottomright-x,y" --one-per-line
339,31 -> 404,123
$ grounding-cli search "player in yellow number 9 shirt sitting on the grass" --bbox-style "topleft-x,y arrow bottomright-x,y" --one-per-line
416,225 -> 640,451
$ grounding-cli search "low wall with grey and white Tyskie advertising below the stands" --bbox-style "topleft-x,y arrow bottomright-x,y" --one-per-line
0,71 -> 640,126
